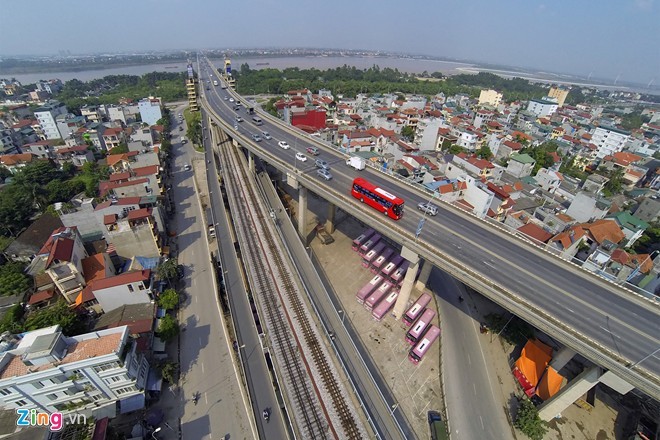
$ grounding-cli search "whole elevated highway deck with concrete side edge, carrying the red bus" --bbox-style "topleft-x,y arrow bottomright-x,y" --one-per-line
200,60 -> 660,399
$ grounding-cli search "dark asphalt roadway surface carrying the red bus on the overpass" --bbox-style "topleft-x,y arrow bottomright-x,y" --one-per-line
201,56 -> 660,397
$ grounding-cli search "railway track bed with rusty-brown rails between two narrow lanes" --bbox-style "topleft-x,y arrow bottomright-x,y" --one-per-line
215,135 -> 365,440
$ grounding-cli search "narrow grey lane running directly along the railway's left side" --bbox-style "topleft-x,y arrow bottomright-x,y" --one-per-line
200,93 -> 288,439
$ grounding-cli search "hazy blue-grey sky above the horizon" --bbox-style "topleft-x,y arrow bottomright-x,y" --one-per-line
0,0 -> 660,84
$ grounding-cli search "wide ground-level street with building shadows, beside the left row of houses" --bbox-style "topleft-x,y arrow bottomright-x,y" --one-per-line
171,107 -> 253,439
